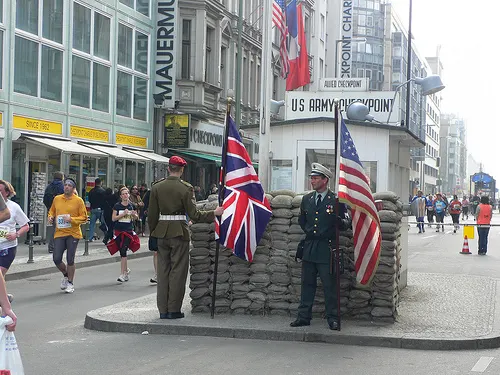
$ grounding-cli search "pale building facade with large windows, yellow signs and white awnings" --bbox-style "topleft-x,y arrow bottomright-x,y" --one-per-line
0,0 -> 172,217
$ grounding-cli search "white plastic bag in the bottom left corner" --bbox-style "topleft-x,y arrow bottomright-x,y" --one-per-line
0,316 -> 24,375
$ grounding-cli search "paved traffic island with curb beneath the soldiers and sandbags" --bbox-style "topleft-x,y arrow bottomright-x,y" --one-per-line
85,272 -> 500,350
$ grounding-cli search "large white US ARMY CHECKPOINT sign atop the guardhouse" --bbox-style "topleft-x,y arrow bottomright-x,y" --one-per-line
285,91 -> 401,124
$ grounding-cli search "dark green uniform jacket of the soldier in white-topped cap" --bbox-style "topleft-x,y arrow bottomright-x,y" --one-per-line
299,190 -> 347,263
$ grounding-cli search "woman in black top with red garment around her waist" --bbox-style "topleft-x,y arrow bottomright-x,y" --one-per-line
112,187 -> 140,283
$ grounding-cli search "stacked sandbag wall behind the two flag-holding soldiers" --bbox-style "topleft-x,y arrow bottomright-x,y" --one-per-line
189,190 -> 402,322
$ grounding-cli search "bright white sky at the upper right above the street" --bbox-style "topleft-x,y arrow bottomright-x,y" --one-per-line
391,0 -> 500,181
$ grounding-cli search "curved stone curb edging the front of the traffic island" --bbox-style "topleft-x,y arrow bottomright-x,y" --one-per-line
84,312 -> 500,350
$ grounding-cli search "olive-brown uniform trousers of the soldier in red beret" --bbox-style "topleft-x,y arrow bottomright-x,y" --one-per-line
156,237 -> 189,314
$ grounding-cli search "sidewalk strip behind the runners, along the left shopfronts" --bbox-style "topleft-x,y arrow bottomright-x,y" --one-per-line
5,237 -> 152,281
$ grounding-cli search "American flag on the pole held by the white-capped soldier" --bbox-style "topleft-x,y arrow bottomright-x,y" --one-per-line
339,119 -> 382,285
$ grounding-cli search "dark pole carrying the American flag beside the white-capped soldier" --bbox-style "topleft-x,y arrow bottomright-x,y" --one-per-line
330,100 -> 341,331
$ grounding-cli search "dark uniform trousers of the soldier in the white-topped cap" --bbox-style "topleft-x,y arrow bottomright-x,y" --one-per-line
298,261 -> 337,321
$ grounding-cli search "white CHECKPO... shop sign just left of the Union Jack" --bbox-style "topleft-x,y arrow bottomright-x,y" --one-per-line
189,122 -> 224,155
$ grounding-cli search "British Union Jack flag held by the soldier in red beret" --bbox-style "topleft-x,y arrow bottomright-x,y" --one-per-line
215,115 -> 271,262
